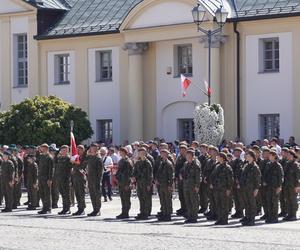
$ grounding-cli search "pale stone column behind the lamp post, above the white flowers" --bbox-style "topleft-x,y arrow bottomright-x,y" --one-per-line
200,35 -> 225,103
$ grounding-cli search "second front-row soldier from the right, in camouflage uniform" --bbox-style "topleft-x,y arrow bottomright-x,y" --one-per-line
263,150 -> 284,223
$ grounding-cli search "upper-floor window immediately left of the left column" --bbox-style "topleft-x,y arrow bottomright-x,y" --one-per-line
96,51 -> 112,82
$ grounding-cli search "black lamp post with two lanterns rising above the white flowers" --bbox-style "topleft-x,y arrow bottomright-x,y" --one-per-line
192,4 -> 228,106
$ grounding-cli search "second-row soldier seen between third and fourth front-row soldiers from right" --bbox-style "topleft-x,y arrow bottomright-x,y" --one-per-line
230,148 -> 244,218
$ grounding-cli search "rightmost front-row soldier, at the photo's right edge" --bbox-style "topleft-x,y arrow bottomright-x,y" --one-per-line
283,150 -> 300,221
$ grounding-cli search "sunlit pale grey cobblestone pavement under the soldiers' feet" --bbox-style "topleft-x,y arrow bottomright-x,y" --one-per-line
0,197 -> 300,250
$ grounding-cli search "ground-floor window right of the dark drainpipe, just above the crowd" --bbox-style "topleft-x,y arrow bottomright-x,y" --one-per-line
259,114 -> 280,139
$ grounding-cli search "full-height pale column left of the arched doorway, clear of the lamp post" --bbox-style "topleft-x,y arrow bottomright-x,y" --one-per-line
124,43 -> 148,142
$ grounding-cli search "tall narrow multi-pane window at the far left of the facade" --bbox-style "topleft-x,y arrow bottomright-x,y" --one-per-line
14,34 -> 28,87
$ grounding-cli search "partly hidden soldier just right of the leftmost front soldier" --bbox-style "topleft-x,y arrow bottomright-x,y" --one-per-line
11,148 -> 24,209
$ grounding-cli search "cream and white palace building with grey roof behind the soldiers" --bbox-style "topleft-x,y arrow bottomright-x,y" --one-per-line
0,0 -> 300,144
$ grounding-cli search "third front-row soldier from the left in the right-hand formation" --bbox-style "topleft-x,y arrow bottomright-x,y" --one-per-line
156,149 -> 174,221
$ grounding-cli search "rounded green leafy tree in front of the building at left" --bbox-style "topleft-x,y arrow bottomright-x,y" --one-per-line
0,96 -> 93,145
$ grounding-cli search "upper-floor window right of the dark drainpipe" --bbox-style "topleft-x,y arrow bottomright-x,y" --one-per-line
260,37 -> 279,72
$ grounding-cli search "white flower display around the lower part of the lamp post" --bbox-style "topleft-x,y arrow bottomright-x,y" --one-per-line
194,103 -> 224,146
